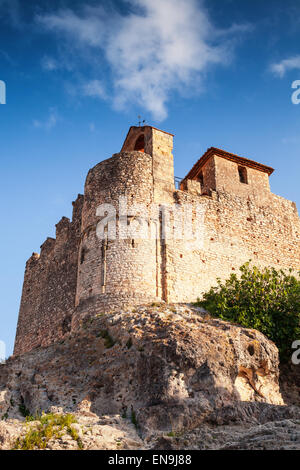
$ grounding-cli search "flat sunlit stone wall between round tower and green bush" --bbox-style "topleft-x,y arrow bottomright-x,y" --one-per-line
166,187 -> 300,302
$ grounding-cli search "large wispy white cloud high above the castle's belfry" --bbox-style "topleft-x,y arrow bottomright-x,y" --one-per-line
37,0 -> 249,120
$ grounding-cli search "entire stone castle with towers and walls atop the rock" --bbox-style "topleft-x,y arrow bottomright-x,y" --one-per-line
14,126 -> 300,355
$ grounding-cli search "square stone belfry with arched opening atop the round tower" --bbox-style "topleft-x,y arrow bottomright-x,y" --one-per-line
121,126 -> 175,203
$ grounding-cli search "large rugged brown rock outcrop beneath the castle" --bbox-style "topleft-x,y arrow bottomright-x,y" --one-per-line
0,304 -> 299,448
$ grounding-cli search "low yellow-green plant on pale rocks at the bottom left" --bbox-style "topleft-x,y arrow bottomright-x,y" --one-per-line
13,413 -> 83,450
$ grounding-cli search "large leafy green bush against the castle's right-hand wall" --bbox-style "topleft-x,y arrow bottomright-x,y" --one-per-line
197,262 -> 300,360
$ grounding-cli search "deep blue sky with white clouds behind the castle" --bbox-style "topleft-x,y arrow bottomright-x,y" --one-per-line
0,0 -> 300,355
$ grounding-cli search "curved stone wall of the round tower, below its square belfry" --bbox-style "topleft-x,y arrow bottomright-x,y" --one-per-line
73,151 -> 160,325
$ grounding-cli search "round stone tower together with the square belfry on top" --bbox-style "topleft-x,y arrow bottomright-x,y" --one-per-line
73,126 -> 174,327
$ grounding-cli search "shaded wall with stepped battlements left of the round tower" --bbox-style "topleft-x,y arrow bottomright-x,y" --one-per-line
14,196 -> 83,354
